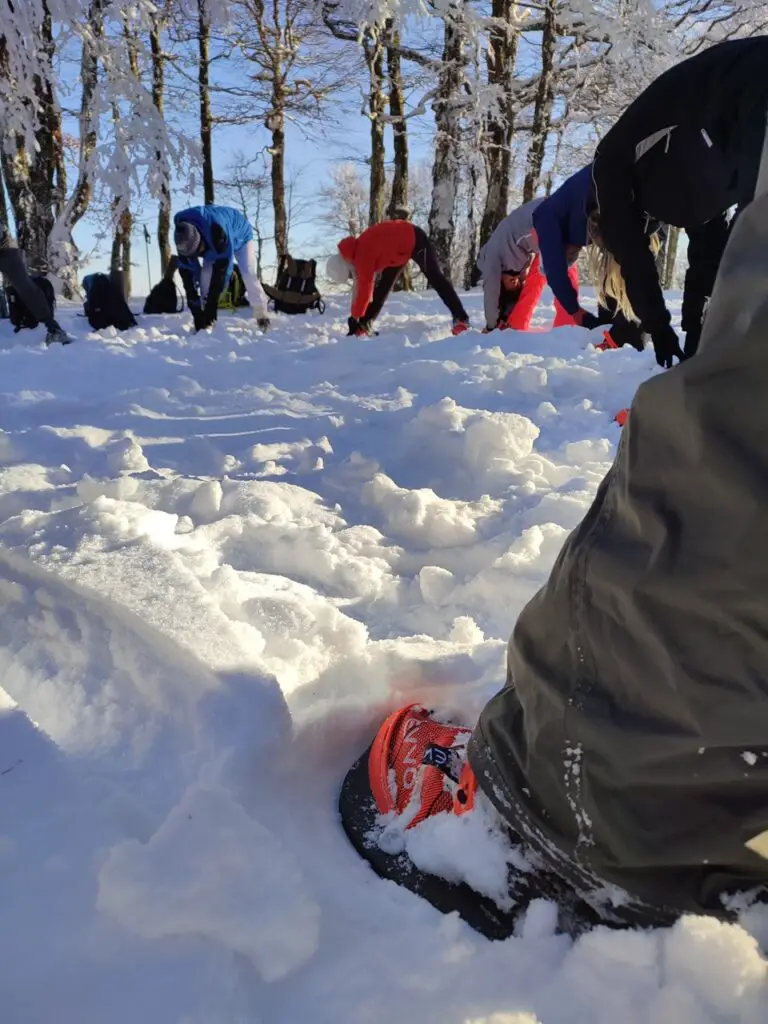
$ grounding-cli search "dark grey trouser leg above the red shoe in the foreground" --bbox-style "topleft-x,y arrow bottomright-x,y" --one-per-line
469,157 -> 768,914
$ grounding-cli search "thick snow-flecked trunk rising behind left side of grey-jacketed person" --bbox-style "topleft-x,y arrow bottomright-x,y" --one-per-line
479,0 -> 519,246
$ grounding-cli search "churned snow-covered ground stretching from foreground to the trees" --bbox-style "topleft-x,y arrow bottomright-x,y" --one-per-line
0,295 -> 768,1024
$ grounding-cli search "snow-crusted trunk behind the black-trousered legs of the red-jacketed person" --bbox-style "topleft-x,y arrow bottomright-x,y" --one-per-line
429,4 -> 465,279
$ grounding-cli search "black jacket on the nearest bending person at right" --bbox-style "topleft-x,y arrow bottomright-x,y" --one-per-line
593,36 -> 768,334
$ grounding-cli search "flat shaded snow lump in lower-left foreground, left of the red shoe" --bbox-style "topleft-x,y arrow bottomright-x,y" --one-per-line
97,787 -> 319,981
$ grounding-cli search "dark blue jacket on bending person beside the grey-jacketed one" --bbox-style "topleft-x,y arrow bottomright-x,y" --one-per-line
534,164 -> 594,315
